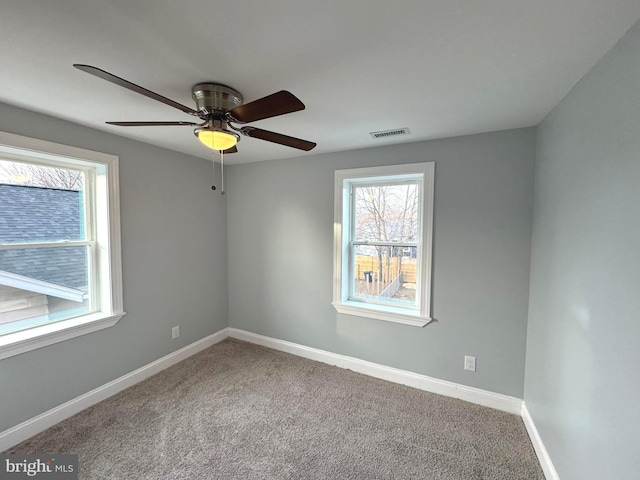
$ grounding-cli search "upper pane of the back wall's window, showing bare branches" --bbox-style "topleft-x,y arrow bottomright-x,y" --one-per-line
353,183 -> 419,242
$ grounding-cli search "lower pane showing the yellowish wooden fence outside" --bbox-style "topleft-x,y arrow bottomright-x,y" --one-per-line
351,245 -> 418,308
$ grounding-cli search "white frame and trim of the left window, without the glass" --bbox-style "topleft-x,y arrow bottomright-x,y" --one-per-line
0,132 -> 125,359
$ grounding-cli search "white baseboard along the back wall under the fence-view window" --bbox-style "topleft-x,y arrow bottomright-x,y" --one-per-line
229,328 -> 522,415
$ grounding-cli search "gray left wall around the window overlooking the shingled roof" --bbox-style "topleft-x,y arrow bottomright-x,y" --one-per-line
0,104 -> 227,431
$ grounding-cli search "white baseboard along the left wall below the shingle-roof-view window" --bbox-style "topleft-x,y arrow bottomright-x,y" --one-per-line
0,328 -> 229,452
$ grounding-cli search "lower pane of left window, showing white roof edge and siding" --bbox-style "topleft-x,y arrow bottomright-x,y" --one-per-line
0,246 -> 90,335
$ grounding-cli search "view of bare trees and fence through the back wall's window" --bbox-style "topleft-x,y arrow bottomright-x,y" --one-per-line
351,183 -> 420,306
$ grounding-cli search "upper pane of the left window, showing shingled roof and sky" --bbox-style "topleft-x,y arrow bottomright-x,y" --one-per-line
0,160 -> 86,243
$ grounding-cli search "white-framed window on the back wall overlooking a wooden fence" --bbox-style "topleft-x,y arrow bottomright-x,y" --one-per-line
333,162 -> 434,326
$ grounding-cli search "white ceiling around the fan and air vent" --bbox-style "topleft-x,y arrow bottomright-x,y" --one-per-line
0,0 -> 640,163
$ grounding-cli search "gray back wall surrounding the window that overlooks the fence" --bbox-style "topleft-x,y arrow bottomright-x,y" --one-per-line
227,129 -> 535,398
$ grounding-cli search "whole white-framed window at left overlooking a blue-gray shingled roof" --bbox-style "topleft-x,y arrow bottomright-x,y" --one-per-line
0,132 -> 124,358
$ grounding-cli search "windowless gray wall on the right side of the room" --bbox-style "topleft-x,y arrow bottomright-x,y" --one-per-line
525,18 -> 640,480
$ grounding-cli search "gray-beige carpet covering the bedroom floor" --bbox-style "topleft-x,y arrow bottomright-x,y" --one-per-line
7,339 -> 544,480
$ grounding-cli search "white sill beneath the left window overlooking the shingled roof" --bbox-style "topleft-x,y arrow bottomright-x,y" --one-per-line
0,312 -> 125,360
